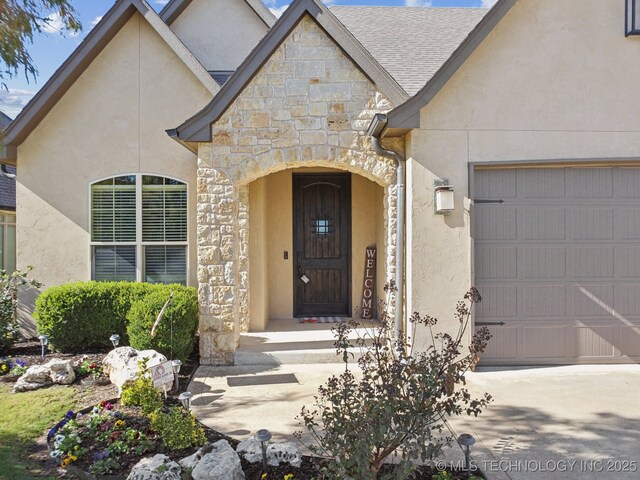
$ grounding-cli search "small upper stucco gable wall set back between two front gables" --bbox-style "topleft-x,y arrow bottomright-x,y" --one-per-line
171,0 -> 268,70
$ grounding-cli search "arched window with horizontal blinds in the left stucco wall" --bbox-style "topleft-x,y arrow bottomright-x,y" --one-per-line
91,175 -> 187,284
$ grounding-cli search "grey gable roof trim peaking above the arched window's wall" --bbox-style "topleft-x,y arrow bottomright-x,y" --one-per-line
2,0 -> 220,163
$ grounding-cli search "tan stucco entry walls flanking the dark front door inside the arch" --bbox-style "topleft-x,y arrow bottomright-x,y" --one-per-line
249,168 -> 386,331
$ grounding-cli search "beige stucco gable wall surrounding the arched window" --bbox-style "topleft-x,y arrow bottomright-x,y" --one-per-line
16,14 -> 210,334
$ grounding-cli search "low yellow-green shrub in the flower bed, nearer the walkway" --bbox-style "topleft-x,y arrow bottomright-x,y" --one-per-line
149,407 -> 207,450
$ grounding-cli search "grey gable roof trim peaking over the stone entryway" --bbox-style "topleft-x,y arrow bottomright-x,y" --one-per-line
167,0 -> 408,142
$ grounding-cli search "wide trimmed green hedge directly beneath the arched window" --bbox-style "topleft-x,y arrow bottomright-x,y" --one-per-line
33,282 -> 198,353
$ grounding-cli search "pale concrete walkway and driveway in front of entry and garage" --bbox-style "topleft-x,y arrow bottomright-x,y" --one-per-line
190,364 -> 640,480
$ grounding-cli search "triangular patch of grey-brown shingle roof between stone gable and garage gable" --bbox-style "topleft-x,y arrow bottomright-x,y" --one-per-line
331,6 -> 489,95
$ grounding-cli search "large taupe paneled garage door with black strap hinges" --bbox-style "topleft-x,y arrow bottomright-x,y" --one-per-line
472,167 -> 640,365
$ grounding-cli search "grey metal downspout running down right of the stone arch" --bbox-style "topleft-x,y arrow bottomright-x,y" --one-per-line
367,113 -> 406,340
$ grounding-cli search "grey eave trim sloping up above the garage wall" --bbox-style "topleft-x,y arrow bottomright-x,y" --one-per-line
378,0 -> 517,135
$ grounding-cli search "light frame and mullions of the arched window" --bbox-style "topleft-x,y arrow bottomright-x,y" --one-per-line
87,172 -> 191,286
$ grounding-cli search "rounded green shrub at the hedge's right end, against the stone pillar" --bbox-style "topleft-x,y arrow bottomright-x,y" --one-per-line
127,285 -> 198,362
